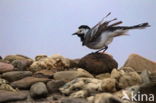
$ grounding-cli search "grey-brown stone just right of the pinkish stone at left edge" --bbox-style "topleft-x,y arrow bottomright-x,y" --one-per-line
12,59 -> 33,71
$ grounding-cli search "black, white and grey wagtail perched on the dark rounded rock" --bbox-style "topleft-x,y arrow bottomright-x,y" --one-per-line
73,13 -> 150,52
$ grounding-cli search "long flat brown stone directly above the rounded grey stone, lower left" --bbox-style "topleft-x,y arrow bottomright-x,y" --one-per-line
11,77 -> 49,89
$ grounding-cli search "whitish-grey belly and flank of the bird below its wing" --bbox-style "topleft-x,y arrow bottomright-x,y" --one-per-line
87,32 -> 113,49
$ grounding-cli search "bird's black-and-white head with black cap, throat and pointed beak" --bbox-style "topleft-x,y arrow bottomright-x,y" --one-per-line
73,25 -> 90,41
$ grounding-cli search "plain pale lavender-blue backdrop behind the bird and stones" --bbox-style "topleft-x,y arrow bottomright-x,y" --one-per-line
0,0 -> 156,66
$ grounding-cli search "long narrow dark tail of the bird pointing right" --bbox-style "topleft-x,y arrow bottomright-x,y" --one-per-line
123,22 -> 150,29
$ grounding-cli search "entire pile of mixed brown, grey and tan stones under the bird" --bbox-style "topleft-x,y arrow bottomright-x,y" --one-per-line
0,53 -> 156,103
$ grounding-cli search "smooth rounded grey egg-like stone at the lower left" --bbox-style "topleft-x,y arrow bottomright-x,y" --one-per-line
30,82 -> 48,98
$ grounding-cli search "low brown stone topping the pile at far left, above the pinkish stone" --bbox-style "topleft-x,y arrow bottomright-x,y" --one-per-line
4,55 -> 33,63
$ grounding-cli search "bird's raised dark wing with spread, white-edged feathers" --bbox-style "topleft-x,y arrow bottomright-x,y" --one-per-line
84,13 -> 122,44
